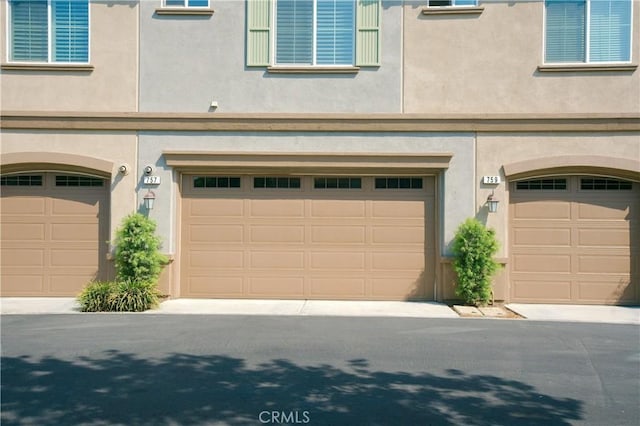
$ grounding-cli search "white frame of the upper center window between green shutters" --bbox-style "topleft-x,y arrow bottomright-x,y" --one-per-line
269,0 -> 358,69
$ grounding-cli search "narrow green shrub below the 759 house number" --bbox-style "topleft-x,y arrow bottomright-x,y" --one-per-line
453,219 -> 500,305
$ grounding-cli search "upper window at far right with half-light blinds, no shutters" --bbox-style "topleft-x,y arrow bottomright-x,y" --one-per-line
545,0 -> 631,63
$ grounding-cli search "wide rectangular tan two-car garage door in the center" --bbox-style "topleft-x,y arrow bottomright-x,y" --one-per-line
180,175 -> 435,300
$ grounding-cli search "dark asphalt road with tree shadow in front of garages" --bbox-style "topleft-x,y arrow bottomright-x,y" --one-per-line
1,314 -> 640,426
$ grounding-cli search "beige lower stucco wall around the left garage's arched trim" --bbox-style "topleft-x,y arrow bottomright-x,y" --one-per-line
0,131 -> 138,238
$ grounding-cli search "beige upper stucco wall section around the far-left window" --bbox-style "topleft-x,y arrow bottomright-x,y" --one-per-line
0,0 -> 138,112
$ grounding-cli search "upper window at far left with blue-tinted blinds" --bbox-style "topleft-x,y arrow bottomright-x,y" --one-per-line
9,0 -> 89,63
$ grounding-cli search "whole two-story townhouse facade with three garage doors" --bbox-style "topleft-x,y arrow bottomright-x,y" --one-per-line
0,0 -> 640,304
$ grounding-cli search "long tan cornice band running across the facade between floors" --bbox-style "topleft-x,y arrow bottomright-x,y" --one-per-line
0,111 -> 640,132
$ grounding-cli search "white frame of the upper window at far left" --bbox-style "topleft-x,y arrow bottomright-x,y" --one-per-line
5,0 -> 91,67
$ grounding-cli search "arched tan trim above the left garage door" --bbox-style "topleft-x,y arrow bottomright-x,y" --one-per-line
0,152 -> 114,178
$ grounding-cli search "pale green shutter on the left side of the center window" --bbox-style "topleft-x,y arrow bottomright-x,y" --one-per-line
247,0 -> 271,67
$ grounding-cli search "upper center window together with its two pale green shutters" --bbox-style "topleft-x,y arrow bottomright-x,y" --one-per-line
247,0 -> 382,67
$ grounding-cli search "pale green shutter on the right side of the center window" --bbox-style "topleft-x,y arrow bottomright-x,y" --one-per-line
356,0 -> 382,66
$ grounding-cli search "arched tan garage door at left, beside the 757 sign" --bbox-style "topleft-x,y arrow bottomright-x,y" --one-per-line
0,173 -> 109,297
